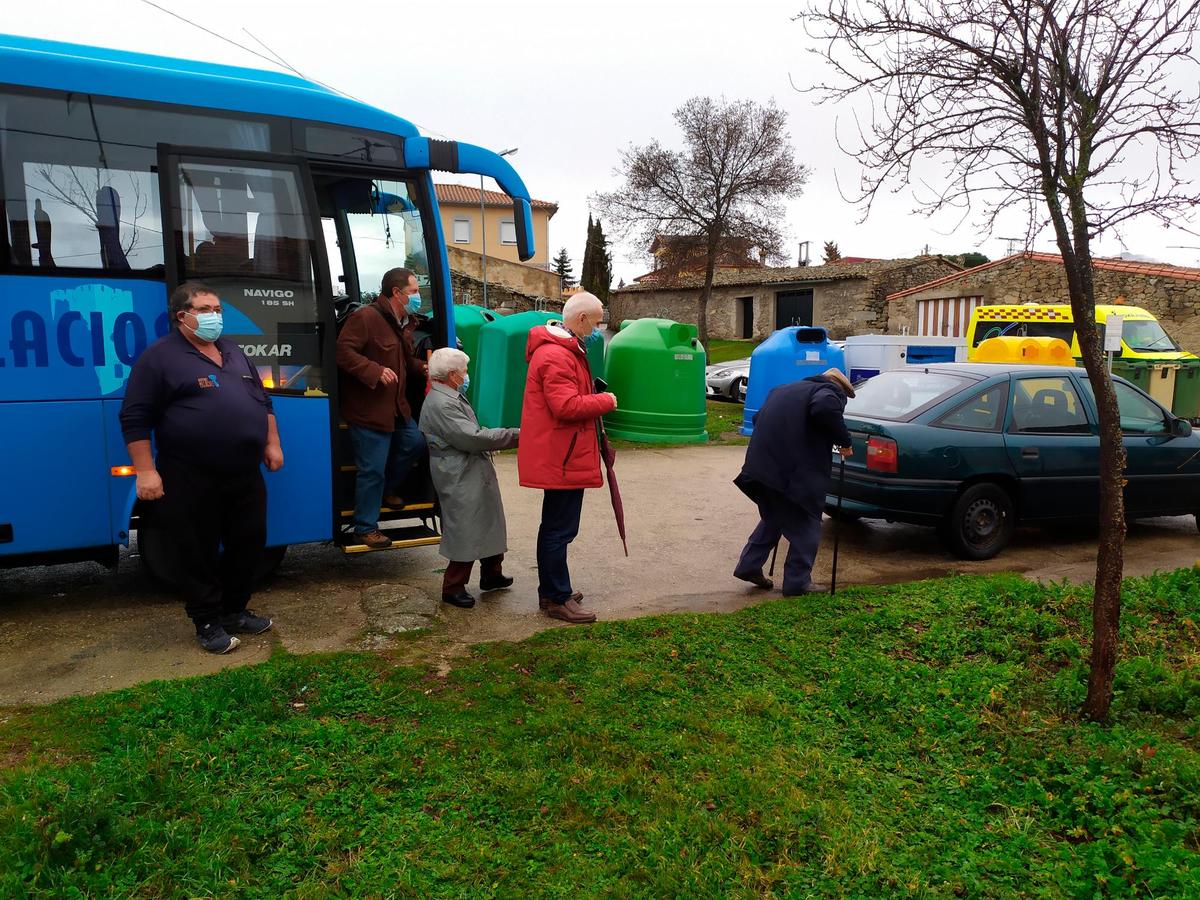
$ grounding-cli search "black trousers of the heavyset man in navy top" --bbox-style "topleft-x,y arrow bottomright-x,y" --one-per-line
153,458 -> 266,626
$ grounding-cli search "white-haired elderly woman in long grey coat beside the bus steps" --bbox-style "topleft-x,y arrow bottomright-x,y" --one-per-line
420,347 -> 520,608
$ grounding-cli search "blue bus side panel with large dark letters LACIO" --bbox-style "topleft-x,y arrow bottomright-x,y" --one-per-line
0,272 -> 168,401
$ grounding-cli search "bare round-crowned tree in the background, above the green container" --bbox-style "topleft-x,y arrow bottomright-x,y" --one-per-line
593,97 -> 809,347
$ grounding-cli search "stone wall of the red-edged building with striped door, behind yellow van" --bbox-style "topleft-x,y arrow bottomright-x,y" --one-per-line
887,258 -> 1200,353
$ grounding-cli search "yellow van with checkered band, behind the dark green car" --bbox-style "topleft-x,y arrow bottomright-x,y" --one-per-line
967,304 -> 1196,362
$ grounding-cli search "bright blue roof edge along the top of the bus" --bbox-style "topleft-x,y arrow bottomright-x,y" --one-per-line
0,35 -> 416,137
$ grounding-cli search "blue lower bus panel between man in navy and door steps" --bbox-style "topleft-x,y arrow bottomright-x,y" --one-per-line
265,395 -> 334,547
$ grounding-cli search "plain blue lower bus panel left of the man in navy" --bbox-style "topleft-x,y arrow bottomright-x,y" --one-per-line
0,401 -> 112,556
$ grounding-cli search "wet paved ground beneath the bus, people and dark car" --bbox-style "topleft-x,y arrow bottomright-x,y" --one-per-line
0,446 -> 1200,704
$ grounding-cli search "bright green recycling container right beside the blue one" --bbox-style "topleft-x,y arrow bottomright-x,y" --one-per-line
605,319 -> 708,444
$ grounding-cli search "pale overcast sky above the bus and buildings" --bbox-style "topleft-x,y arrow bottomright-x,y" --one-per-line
9,0 -> 1200,281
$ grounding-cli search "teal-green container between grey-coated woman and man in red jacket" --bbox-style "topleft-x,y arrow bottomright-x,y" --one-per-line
467,310 -> 559,428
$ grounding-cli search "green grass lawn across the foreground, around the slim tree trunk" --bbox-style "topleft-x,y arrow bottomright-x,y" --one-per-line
0,570 -> 1200,898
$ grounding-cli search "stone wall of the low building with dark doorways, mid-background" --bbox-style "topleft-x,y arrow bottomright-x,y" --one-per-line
610,257 -> 958,340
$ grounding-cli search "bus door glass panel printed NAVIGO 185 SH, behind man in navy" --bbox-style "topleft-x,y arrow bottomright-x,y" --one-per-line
172,158 -> 323,390
